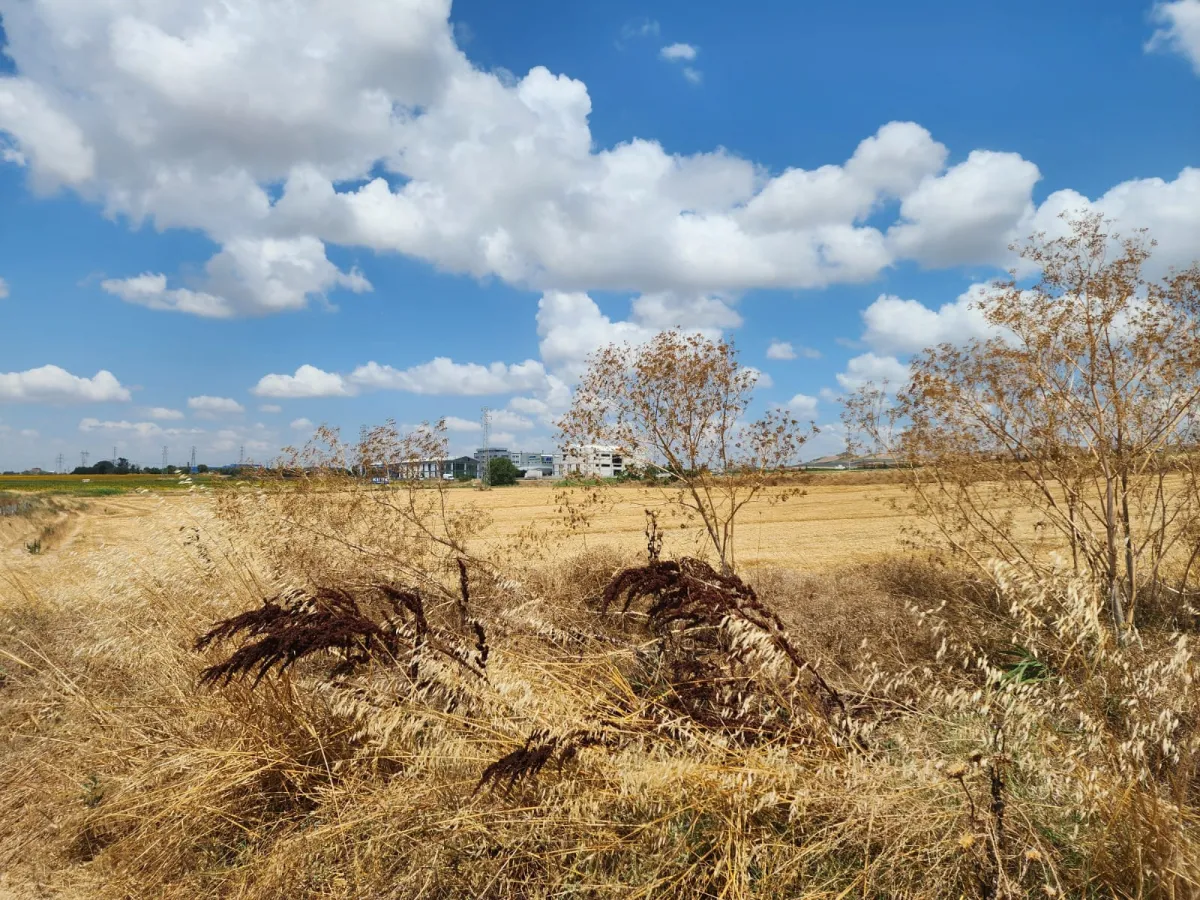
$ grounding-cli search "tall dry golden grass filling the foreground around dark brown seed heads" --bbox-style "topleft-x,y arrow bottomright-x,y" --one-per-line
0,486 -> 1200,899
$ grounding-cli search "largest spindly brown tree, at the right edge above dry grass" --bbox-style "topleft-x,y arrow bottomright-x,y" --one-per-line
846,215 -> 1200,634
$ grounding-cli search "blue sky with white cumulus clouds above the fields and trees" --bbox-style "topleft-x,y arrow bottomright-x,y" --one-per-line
0,0 -> 1200,469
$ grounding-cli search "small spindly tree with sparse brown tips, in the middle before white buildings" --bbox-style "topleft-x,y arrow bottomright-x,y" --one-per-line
559,330 -> 814,572
